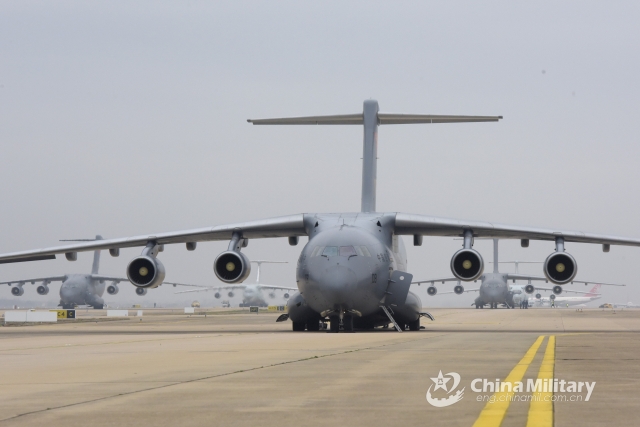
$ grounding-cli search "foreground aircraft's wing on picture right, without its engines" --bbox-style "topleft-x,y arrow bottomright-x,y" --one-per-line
396,212 -> 640,247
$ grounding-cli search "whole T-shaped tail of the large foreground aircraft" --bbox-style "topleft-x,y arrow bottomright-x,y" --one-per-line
247,99 -> 502,212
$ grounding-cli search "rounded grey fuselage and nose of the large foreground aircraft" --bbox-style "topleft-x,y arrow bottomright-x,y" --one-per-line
291,213 -> 422,321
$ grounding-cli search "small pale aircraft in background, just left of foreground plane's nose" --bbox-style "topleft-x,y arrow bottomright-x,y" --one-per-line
165,260 -> 298,307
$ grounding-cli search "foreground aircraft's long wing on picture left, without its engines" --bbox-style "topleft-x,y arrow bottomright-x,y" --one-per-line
0,214 -> 307,264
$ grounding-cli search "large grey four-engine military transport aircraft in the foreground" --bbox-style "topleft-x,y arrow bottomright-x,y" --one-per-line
0,100 -> 640,332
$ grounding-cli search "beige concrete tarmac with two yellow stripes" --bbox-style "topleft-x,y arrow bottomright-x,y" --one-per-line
0,308 -> 640,427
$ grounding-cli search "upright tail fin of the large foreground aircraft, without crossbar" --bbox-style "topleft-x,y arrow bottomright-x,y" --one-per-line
361,99 -> 378,212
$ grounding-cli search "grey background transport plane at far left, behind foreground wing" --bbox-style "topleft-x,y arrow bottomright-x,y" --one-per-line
0,236 -> 130,309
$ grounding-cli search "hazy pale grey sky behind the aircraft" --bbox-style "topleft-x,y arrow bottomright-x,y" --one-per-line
0,0 -> 640,306
